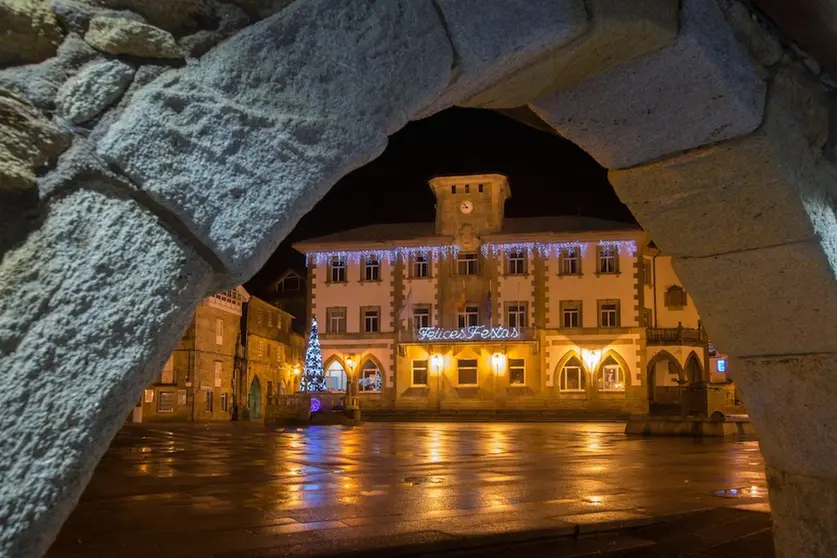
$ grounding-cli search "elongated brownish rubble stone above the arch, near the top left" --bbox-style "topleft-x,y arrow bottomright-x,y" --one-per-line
84,16 -> 183,58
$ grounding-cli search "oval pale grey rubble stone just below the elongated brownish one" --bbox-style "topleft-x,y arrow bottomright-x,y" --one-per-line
56,60 -> 134,124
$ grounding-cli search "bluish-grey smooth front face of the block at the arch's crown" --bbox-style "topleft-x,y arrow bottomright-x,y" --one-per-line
418,0 -> 587,118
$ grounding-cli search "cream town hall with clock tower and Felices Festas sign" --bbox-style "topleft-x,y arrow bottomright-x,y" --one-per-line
295,174 -> 729,414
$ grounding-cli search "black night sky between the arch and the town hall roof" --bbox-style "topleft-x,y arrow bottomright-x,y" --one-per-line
246,108 -> 635,294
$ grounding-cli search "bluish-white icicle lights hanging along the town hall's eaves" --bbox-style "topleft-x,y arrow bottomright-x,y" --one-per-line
305,240 -> 637,265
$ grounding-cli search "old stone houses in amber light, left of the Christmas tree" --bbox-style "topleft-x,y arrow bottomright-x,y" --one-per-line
136,287 -> 303,422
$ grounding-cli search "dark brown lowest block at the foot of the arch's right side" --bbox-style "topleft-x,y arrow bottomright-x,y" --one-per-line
767,468 -> 837,558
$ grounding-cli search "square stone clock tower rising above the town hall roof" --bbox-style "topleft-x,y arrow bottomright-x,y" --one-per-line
430,174 -> 510,240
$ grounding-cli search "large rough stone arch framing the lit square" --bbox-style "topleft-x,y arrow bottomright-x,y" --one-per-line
0,0 -> 837,556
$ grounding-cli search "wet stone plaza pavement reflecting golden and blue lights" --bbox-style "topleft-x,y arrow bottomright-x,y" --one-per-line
49,423 -> 769,557
